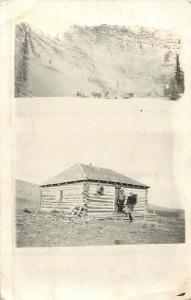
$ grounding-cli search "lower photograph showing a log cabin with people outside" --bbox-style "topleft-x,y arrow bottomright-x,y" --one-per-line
15,119 -> 185,247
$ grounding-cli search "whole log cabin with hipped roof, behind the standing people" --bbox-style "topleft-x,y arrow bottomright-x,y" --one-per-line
41,164 -> 149,217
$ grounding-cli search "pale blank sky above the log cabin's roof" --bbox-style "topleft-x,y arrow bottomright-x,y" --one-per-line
14,101 -> 184,207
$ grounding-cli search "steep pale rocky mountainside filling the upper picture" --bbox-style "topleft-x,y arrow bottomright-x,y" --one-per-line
15,23 -> 180,97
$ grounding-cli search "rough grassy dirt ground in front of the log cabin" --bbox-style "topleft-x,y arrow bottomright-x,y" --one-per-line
16,211 -> 185,247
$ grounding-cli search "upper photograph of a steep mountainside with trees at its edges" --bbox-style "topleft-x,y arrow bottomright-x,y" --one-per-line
15,5 -> 184,101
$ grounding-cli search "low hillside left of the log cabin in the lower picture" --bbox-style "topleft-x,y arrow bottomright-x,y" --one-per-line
16,180 -> 40,209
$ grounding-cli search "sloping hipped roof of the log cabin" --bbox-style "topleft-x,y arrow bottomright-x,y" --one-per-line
41,164 -> 149,188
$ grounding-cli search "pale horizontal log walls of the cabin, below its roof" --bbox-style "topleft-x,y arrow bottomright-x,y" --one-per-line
41,181 -> 147,216
